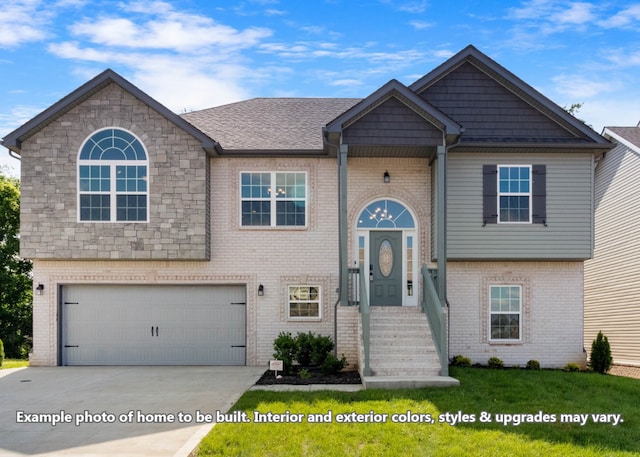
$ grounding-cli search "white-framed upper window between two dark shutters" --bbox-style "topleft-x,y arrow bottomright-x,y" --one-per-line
498,165 -> 531,223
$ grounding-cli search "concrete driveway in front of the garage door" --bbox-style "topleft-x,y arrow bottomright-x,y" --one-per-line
0,367 -> 265,457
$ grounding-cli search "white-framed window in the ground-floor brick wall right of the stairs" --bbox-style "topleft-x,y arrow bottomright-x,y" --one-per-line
489,285 -> 522,341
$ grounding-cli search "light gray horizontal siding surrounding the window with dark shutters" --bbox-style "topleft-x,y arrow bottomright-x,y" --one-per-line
447,153 -> 593,260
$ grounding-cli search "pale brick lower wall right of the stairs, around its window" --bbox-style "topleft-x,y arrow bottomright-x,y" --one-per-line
447,262 -> 585,368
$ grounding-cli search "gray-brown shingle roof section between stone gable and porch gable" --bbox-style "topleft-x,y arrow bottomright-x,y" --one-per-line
181,98 -> 361,150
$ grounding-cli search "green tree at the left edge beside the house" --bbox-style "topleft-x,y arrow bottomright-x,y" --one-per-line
0,170 -> 32,358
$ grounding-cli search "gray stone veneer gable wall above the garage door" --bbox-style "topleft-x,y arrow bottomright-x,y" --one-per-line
20,84 -> 210,260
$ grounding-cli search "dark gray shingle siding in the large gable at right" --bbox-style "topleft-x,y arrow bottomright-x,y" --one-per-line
420,63 -> 574,141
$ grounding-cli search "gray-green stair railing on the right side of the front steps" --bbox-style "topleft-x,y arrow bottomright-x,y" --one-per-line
422,265 -> 449,376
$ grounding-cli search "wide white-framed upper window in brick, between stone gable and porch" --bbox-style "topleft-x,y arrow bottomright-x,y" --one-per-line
240,172 -> 308,227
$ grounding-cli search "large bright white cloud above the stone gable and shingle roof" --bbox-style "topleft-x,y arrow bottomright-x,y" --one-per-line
43,1 -> 278,112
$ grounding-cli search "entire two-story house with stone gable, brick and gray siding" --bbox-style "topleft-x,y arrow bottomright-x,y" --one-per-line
3,46 -> 611,382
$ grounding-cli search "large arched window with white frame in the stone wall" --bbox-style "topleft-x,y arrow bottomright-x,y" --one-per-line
78,128 -> 148,222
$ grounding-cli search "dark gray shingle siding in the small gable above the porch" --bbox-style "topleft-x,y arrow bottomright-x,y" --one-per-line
343,97 -> 442,146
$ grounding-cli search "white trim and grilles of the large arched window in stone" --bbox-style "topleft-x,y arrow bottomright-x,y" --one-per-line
76,126 -> 151,224
